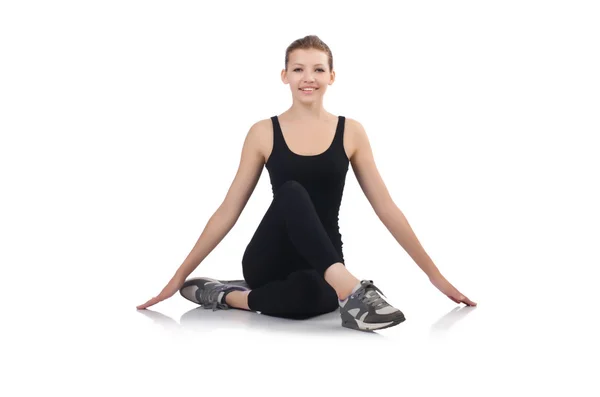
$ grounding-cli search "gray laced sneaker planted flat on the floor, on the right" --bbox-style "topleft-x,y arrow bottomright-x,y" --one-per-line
339,280 -> 405,331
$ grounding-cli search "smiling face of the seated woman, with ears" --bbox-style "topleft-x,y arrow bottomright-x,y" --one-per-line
281,49 -> 335,102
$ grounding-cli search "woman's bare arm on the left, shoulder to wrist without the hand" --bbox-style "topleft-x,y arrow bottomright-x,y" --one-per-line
175,123 -> 264,279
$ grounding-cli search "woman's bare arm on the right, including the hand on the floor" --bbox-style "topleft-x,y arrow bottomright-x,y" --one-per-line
346,118 -> 476,306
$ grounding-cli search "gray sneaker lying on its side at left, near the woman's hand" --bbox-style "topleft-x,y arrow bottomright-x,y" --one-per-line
179,277 -> 250,311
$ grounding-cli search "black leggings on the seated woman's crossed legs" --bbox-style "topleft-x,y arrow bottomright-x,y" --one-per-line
242,181 -> 344,319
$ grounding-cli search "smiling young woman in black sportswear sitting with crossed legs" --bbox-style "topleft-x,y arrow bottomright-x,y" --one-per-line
137,36 -> 476,331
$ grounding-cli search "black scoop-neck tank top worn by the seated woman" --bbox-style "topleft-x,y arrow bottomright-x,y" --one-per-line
265,116 -> 350,263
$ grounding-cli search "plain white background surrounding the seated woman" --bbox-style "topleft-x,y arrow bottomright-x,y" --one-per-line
0,0 -> 600,396
